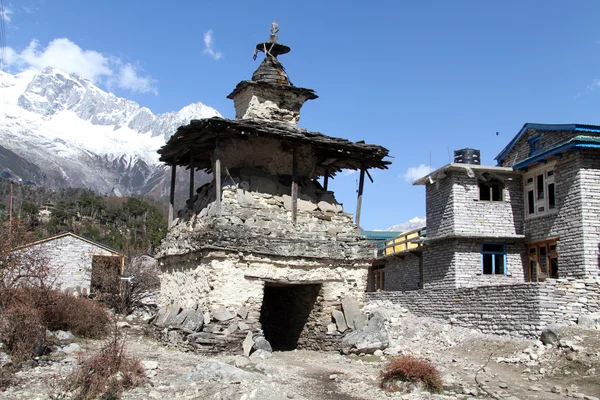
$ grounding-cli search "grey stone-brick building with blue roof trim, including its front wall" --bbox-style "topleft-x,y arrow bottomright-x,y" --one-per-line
369,124 -> 600,334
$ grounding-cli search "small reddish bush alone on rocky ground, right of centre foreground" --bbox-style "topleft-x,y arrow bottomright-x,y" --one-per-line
380,355 -> 444,393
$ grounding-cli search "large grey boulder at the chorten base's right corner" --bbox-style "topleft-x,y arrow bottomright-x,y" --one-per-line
342,315 -> 390,354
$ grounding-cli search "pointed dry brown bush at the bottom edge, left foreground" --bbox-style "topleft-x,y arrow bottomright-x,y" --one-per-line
65,328 -> 147,400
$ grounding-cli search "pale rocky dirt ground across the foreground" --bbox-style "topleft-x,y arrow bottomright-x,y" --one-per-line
0,309 -> 600,400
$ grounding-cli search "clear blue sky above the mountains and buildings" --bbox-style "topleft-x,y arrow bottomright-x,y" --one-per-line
4,0 -> 600,229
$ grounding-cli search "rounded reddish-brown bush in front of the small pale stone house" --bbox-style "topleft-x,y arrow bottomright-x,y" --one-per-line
41,291 -> 110,339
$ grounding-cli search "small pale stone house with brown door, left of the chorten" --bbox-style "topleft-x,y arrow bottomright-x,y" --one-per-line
20,232 -> 125,296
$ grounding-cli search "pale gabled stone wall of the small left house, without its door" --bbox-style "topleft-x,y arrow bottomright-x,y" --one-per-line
28,236 -> 120,295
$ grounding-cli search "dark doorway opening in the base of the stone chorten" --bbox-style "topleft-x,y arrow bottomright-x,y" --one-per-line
260,283 -> 321,351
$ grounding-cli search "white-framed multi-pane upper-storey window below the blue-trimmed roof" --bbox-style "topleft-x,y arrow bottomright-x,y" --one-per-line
523,164 -> 557,218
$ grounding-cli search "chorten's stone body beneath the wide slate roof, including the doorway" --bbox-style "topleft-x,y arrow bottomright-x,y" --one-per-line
157,168 -> 372,352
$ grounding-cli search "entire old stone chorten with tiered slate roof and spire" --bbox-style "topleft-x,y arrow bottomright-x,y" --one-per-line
156,27 -> 390,352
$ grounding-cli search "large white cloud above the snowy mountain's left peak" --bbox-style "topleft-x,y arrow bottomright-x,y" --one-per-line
6,38 -> 158,95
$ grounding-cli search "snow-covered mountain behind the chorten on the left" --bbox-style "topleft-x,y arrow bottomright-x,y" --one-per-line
0,67 -> 220,197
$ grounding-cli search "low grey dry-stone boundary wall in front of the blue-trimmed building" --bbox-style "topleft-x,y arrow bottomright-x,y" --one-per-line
365,277 -> 600,337
